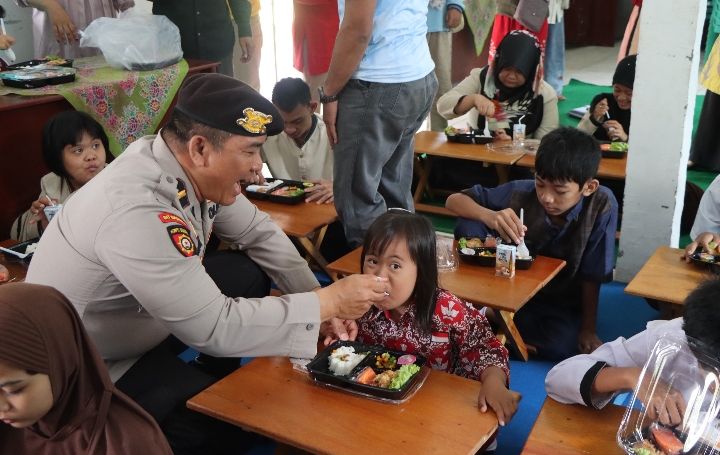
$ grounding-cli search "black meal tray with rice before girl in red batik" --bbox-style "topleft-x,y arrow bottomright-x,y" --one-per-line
307,341 -> 427,400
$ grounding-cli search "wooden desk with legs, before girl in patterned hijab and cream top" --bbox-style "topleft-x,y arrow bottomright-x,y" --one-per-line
413,131 -> 523,216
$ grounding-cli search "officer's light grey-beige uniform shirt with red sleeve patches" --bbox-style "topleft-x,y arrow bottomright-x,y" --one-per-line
27,135 -> 320,381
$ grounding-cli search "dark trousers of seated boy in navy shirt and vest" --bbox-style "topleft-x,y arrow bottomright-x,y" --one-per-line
513,299 -> 582,361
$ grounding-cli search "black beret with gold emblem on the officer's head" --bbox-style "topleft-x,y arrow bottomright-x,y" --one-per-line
175,73 -> 285,136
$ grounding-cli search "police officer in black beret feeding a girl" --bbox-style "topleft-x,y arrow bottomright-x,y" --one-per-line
27,74 -> 387,453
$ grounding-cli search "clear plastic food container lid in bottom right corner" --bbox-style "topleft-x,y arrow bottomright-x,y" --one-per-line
617,331 -> 720,455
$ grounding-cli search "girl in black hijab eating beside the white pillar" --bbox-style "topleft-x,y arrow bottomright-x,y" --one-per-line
578,55 -> 637,142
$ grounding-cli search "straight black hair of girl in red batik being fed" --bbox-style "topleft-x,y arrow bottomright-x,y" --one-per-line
360,209 -> 438,334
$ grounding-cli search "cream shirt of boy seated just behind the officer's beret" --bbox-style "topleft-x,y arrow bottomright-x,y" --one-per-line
260,114 -> 333,181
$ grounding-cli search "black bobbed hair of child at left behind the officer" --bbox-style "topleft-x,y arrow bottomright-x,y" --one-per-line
42,111 -> 115,178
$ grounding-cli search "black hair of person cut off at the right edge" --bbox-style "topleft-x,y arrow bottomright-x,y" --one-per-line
683,276 -> 720,359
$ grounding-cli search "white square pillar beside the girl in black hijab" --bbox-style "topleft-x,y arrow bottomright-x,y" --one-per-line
616,0 -> 707,281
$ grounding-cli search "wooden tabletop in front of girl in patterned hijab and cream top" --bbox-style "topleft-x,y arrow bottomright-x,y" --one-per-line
415,131 -> 523,165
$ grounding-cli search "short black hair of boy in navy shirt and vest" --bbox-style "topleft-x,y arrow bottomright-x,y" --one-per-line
535,126 -> 602,188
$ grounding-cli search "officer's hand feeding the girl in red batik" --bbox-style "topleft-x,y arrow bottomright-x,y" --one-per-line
315,275 -> 388,321
